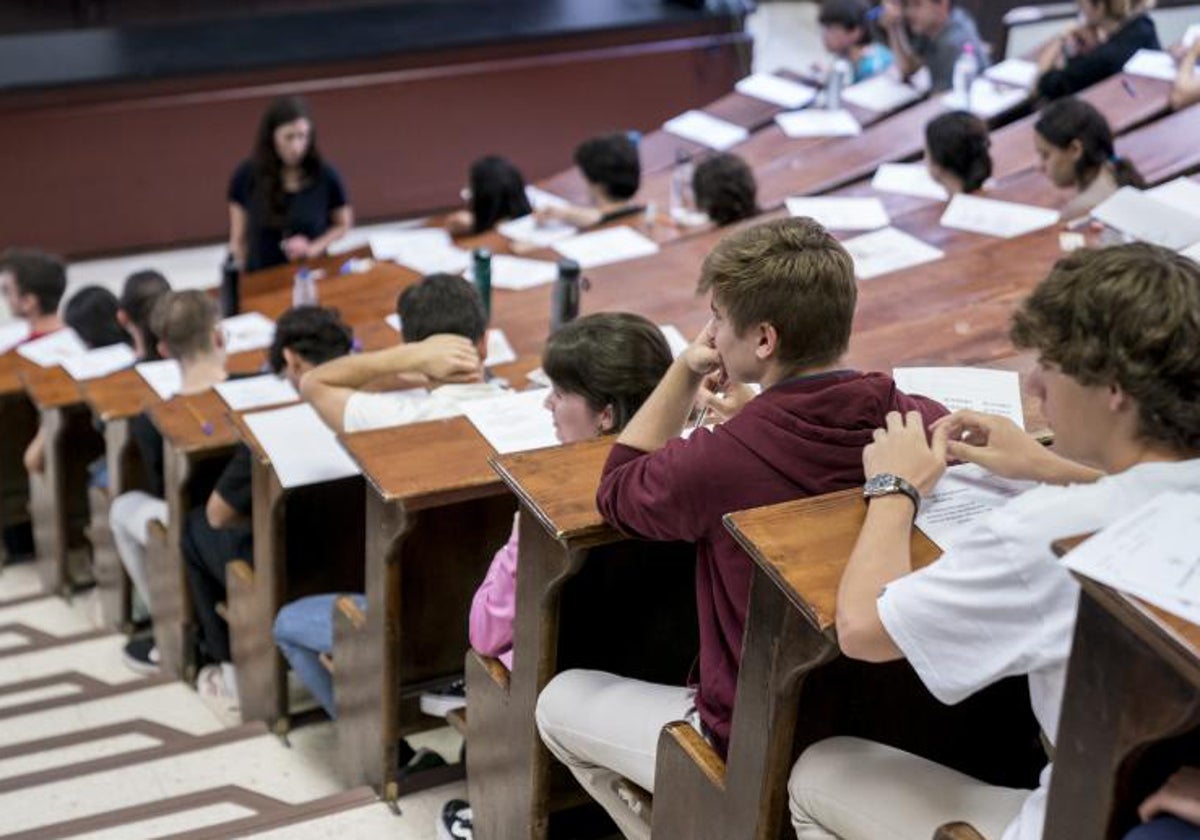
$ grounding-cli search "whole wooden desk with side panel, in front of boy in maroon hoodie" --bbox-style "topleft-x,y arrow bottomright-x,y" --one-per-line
467,439 -> 698,840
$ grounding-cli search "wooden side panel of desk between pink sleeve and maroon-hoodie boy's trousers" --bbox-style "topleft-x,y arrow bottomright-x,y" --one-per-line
467,510 -> 586,840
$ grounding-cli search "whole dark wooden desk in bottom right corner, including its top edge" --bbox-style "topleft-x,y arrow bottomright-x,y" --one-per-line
1045,540 -> 1200,840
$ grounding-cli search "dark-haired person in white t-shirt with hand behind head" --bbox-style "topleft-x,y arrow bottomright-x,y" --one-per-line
301,274 -> 502,432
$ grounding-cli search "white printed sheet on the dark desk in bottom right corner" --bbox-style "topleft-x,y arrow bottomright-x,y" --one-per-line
1063,492 -> 1200,624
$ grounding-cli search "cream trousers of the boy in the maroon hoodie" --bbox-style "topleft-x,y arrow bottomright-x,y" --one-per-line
536,670 -> 698,840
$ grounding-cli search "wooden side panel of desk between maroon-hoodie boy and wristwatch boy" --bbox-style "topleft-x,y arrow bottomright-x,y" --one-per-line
654,569 -> 838,840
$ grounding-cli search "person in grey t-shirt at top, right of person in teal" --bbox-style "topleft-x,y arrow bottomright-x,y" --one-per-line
880,0 -> 986,91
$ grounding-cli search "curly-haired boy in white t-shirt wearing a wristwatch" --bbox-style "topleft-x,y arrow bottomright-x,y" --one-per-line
788,244 -> 1200,840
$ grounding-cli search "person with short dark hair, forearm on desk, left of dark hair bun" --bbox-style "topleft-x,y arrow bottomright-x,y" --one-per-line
538,132 -> 642,228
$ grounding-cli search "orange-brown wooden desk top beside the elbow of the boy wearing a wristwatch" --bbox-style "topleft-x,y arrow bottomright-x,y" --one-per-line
725,487 -> 941,632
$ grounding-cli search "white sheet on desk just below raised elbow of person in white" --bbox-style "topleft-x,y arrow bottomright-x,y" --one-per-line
245,402 -> 362,487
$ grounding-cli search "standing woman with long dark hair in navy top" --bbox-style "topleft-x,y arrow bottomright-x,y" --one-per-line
229,96 -> 354,271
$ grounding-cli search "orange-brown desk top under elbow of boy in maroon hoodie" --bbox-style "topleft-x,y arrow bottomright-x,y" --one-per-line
492,436 -> 616,542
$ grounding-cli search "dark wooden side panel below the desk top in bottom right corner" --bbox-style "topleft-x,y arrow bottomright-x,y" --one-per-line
1045,593 -> 1200,840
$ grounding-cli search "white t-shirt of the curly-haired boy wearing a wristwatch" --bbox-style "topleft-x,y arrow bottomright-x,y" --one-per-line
878,460 -> 1200,840
